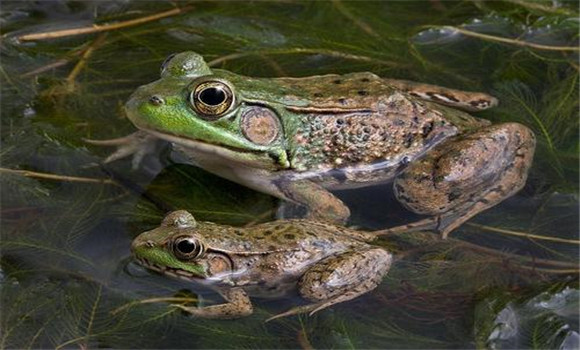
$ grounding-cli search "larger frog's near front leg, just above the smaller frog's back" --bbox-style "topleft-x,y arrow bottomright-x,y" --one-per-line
276,180 -> 350,225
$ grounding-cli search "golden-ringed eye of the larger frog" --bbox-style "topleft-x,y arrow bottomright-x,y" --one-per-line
189,80 -> 234,119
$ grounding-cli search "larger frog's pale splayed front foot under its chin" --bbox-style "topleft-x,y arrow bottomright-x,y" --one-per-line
83,131 -> 158,169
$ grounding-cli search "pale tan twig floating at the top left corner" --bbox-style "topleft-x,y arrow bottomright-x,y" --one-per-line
17,7 -> 190,41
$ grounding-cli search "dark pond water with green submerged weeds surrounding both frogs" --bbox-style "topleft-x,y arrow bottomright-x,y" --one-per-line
0,1 -> 579,348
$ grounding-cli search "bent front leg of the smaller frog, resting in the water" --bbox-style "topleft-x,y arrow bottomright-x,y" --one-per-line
171,288 -> 254,319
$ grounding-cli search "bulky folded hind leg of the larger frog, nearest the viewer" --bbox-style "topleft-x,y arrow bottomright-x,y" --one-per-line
394,123 -> 535,236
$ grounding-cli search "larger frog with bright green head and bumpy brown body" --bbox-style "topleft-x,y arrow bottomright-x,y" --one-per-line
98,52 -> 535,237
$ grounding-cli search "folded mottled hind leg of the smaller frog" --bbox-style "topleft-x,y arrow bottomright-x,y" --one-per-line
266,248 -> 393,321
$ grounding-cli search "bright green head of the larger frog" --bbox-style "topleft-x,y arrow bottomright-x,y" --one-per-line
125,52 -> 288,168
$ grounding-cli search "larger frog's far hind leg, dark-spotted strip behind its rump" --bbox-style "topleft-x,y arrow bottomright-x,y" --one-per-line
385,79 -> 498,112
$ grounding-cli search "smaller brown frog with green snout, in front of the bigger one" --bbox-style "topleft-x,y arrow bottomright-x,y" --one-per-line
131,210 -> 392,319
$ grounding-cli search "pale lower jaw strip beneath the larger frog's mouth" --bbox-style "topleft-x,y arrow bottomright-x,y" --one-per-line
143,129 -> 290,169
